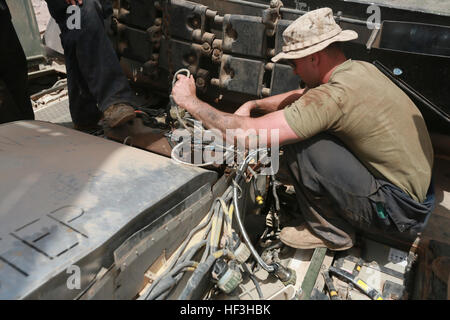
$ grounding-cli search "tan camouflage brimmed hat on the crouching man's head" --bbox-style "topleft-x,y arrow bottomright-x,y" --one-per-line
272,8 -> 358,62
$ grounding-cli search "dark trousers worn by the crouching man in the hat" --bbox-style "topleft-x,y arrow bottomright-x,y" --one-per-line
285,134 -> 434,246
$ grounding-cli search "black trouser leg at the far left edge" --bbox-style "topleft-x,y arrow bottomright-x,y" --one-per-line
0,10 -> 34,123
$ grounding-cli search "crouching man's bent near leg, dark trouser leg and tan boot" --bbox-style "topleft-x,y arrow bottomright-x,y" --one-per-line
280,134 -> 391,250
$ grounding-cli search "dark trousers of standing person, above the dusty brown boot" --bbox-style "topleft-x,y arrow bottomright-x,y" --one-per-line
46,0 -> 138,125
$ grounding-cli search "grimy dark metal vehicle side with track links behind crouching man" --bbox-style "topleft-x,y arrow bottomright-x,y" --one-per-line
112,0 -> 450,131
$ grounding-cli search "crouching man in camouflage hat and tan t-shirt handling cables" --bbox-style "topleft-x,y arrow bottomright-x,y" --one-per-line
172,8 -> 434,250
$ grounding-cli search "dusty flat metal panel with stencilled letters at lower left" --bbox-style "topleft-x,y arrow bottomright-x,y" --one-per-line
0,121 -> 216,299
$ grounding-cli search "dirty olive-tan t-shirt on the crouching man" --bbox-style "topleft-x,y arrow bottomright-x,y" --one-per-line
284,60 -> 433,202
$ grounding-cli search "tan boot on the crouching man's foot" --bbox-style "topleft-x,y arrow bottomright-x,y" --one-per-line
280,223 -> 354,251
